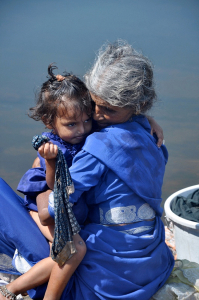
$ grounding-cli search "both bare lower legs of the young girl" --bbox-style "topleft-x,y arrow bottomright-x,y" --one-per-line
0,234 -> 86,300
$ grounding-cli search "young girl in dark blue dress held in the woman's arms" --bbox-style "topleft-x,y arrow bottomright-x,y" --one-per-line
0,64 -> 92,299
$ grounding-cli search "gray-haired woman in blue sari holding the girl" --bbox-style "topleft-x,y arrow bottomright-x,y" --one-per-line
0,41 -> 174,300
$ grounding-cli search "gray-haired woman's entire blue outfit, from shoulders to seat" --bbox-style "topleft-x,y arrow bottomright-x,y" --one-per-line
0,116 -> 174,300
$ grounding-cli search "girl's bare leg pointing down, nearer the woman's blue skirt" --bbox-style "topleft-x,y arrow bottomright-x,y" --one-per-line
44,234 -> 86,300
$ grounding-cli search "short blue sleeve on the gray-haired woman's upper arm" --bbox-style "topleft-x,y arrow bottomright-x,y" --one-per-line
70,150 -> 107,203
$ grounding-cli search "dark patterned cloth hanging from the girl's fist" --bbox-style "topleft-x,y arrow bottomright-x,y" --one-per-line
32,136 -> 81,266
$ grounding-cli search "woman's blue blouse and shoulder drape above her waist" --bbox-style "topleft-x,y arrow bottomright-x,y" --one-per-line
70,116 -> 168,218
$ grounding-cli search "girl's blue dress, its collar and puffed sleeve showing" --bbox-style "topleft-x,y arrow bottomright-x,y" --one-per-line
17,132 -> 84,211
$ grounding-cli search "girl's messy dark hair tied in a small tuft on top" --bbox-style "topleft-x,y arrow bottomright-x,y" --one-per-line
28,63 -> 91,125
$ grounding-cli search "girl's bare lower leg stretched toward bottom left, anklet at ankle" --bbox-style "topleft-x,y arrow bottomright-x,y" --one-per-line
0,257 -> 56,300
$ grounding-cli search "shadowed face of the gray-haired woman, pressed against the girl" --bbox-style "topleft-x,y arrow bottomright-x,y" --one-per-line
90,93 -> 133,128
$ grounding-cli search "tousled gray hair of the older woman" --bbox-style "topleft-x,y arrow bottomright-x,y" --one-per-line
85,40 -> 156,114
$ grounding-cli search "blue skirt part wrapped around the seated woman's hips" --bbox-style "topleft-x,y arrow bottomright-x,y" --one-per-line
61,217 -> 173,300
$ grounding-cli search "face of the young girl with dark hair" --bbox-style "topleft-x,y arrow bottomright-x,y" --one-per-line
47,108 -> 92,145
